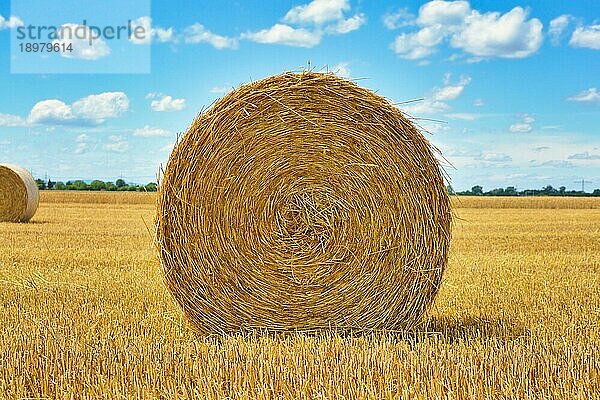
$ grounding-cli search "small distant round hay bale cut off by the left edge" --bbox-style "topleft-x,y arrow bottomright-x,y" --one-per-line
0,164 -> 40,222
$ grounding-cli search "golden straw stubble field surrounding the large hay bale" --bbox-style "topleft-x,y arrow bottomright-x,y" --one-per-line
0,193 -> 600,399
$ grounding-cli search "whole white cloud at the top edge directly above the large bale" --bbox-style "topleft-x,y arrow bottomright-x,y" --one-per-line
241,0 -> 367,48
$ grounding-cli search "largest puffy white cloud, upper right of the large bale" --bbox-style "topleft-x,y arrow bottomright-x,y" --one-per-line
390,0 -> 543,61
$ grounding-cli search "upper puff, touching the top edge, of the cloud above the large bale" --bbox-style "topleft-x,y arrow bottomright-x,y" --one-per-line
283,0 -> 350,25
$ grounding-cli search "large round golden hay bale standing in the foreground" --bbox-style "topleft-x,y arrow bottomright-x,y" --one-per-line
157,72 -> 451,333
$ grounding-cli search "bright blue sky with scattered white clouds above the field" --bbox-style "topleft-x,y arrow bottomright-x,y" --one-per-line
0,0 -> 600,191
